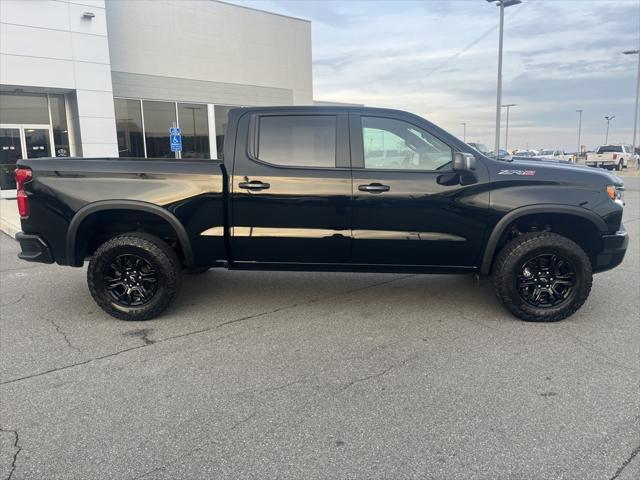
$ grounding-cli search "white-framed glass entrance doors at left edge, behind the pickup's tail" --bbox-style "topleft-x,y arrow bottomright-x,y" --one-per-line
0,125 -> 52,198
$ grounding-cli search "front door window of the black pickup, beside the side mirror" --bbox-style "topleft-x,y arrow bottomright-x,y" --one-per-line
362,117 -> 453,170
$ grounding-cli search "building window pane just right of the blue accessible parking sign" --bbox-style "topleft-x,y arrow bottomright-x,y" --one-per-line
178,103 -> 211,158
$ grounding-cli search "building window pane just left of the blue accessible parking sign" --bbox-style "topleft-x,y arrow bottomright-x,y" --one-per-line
142,100 -> 177,158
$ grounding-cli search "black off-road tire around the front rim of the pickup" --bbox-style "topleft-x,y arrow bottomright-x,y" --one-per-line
493,232 -> 593,322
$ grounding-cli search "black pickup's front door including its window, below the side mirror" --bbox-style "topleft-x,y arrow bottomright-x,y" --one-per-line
350,113 -> 488,268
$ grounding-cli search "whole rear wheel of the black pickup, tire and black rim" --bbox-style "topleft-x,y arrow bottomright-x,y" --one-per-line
87,232 -> 181,321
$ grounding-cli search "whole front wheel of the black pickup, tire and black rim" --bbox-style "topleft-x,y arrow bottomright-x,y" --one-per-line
493,232 -> 592,322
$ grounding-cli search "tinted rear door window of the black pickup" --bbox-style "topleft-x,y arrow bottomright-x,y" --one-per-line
257,115 -> 337,167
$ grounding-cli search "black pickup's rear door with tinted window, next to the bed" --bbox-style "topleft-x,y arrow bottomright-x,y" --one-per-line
230,108 -> 352,266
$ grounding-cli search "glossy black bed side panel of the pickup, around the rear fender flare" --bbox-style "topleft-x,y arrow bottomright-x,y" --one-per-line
18,158 -> 224,264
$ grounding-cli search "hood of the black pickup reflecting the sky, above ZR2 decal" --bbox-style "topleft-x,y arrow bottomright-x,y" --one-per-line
504,158 -> 623,187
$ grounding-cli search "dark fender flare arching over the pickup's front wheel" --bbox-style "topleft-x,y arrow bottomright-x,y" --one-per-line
480,204 -> 607,275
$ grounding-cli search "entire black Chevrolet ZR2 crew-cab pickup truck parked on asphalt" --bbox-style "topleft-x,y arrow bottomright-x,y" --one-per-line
16,107 -> 628,321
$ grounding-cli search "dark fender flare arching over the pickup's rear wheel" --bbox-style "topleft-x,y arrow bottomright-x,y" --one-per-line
66,200 -> 193,267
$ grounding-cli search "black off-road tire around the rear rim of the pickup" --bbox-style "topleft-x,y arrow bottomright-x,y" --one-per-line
87,232 -> 182,321
